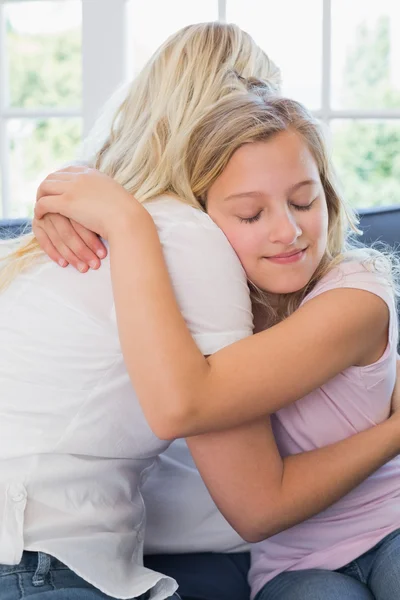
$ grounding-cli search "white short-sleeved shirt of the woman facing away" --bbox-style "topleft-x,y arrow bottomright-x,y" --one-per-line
0,197 -> 252,600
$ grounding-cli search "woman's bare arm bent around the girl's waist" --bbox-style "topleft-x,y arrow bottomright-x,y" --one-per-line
187,406 -> 400,542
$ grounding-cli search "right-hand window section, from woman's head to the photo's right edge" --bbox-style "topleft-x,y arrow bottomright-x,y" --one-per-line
226,0 -> 400,207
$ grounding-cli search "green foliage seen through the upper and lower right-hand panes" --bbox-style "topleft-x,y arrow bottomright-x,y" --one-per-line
333,17 -> 400,207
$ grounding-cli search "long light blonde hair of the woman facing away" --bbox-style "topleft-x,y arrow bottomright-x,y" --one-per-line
0,22 -> 280,291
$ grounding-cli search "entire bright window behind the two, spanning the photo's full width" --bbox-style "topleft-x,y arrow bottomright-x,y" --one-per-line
0,0 -> 400,217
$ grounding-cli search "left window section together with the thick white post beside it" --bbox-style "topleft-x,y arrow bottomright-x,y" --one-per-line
0,0 -> 126,218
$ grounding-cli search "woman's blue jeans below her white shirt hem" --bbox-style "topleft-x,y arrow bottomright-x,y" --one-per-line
0,552 -> 179,600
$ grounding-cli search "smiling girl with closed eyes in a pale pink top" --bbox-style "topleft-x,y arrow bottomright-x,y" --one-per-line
36,92 -> 400,600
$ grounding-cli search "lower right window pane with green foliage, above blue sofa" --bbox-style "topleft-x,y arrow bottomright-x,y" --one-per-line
332,119 -> 400,207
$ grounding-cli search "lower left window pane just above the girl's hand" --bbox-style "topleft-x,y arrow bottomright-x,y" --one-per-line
7,118 -> 82,217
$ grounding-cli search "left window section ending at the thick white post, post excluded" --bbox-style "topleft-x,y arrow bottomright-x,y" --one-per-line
0,0 -> 82,217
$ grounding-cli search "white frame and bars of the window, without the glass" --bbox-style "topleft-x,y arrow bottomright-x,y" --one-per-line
0,0 -> 400,218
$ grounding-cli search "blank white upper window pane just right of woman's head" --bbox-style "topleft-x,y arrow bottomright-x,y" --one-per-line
227,0 -> 322,109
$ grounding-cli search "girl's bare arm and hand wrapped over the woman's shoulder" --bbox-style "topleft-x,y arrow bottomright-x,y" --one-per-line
36,169 -> 388,439
